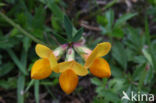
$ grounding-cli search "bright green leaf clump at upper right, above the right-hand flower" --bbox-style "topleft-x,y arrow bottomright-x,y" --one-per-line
97,9 -> 136,38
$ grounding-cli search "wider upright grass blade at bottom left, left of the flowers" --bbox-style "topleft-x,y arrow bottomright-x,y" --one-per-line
17,75 -> 25,103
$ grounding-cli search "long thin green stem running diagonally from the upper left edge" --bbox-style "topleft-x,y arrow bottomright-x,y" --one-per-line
0,12 -> 45,44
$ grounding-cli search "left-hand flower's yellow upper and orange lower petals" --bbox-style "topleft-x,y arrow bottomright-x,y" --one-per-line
31,44 -> 57,80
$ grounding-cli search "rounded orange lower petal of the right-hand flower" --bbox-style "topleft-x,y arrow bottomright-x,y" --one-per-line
89,58 -> 111,78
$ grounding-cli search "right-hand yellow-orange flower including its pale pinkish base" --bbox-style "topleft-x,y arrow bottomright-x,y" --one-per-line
75,42 -> 111,78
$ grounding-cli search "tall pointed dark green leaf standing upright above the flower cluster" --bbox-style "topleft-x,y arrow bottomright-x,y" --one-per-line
64,16 -> 73,40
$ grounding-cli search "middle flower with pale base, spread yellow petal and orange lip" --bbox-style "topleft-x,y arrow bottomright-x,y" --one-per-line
54,48 -> 88,94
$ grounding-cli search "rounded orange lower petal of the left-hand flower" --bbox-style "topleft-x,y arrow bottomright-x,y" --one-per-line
31,58 -> 52,80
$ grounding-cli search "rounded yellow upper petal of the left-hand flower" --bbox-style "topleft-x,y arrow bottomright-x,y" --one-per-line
35,44 -> 52,58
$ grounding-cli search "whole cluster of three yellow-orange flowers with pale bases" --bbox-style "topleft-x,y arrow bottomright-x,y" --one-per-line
31,42 -> 111,94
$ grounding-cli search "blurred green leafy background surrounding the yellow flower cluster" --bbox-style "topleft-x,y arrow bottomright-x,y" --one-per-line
0,0 -> 156,103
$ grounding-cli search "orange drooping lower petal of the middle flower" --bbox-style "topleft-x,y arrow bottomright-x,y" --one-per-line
59,69 -> 78,94
